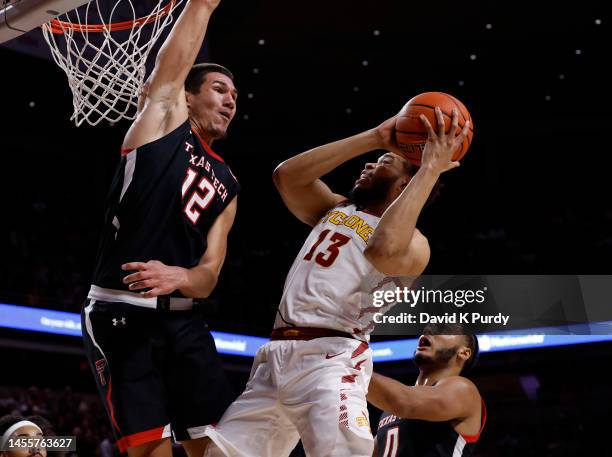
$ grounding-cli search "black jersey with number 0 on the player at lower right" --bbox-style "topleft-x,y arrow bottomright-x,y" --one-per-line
376,402 -> 487,457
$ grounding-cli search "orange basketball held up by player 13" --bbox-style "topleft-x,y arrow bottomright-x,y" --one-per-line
395,92 -> 474,166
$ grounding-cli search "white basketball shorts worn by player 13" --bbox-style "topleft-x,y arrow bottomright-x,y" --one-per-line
205,337 -> 374,457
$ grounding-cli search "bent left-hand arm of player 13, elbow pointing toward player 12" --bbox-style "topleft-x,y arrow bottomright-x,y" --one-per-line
273,123 -> 394,226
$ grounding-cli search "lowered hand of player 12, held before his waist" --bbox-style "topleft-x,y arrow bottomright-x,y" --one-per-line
121,260 -> 187,298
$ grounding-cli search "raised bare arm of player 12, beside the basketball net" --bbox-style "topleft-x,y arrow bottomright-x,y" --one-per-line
123,0 -> 220,149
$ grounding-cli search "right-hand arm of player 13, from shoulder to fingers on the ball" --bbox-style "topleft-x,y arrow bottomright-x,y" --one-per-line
364,108 -> 470,276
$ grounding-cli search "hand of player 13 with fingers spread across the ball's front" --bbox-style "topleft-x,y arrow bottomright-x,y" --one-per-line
419,106 -> 470,174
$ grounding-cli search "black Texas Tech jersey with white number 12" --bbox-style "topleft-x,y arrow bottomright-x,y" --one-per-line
93,121 -> 240,296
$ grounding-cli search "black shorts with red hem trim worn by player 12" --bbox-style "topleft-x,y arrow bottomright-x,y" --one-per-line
82,300 -> 234,452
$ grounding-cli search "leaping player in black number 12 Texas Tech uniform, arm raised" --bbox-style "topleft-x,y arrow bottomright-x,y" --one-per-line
82,0 -> 239,457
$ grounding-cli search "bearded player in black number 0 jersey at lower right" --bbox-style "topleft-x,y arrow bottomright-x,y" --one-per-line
368,326 -> 487,457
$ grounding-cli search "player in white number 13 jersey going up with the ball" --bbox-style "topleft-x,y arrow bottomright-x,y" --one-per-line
205,108 -> 469,457
